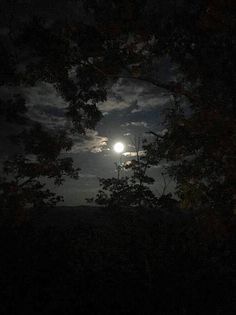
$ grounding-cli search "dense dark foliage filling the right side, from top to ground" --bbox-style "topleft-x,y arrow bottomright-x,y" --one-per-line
139,0 -> 236,215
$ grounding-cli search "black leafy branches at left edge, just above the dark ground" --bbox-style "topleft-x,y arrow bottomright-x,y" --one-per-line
0,124 -> 79,223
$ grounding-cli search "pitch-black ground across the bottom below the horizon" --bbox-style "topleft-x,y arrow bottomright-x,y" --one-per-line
0,207 -> 236,315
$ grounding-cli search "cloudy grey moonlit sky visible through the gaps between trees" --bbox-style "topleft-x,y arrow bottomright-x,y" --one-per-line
28,77 -> 175,205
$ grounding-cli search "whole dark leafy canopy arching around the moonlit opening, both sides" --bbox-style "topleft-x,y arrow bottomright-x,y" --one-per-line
0,0 -> 236,220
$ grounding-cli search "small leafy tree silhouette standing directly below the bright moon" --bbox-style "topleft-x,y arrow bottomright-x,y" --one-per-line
91,137 -> 157,208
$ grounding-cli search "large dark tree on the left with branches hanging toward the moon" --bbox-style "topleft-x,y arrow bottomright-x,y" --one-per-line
0,6 -> 149,220
